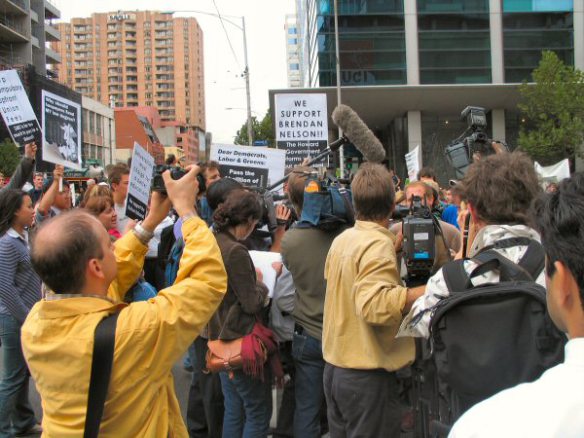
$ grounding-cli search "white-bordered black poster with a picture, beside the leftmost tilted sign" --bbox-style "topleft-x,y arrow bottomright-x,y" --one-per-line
41,90 -> 81,170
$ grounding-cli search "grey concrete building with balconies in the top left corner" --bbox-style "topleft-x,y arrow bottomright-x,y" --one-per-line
0,0 -> 61,75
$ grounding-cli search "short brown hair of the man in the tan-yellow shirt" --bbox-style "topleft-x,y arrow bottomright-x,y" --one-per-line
351,162 -> 395,221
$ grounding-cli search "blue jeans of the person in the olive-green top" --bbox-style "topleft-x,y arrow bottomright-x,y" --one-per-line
292,332 -> 325,438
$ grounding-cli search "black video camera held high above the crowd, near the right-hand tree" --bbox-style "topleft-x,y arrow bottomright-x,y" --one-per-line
445,106 -> 504,178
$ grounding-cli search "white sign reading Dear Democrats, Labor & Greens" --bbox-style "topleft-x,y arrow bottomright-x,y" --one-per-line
211,143 -> 286,188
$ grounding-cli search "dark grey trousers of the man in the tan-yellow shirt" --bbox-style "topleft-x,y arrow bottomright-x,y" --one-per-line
324,363 -> 401,438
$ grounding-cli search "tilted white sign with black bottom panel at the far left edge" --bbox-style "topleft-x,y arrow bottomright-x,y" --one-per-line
0,70 -> 41,146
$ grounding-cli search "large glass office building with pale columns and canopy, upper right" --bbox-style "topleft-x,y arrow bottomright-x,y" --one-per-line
282,0 -> 584,179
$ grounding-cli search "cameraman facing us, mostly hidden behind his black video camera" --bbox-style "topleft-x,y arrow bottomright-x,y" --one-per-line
390,181 -> 461,284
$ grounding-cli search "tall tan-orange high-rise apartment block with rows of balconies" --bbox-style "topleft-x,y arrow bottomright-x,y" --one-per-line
53,11 -> 205,130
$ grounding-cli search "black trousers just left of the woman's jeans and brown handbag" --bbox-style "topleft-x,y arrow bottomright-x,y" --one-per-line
187,337 -> 225,438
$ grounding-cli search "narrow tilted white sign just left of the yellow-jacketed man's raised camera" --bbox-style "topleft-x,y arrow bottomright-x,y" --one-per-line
126,143 -> 154,220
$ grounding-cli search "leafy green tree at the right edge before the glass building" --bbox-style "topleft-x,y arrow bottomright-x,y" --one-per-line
518,51 -> 584,165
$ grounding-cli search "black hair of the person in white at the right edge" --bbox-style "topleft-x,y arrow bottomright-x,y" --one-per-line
532,172 -> 584,310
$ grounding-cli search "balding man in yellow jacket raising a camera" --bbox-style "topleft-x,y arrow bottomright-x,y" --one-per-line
22,168 -> 227,438
